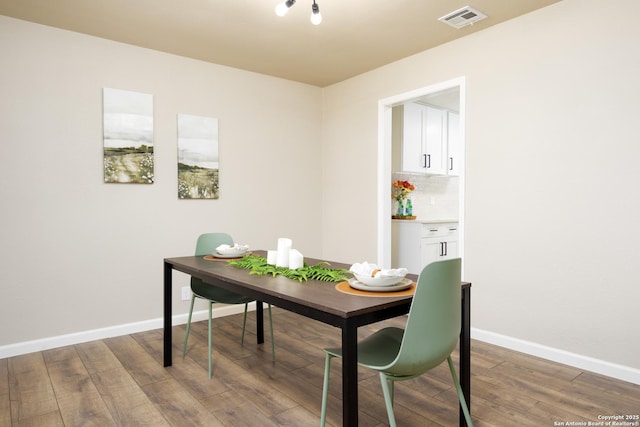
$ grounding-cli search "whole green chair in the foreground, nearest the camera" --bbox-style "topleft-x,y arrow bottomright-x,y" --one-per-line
320,258 -> 473,427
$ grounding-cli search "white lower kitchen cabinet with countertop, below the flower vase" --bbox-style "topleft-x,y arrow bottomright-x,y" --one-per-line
391,220 -> 458,274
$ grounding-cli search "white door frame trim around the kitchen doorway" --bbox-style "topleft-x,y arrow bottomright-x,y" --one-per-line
377,77 -> 466,268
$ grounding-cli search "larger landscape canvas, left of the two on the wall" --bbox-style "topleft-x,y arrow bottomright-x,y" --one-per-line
103,88 -> 154,184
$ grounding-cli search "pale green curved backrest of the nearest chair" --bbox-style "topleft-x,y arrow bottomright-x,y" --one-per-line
385,258 -> 462,375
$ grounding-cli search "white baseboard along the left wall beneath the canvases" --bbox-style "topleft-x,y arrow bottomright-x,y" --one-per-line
0,302 -> 256,359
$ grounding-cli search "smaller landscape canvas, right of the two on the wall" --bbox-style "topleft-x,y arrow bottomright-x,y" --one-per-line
178,114 -> 220,199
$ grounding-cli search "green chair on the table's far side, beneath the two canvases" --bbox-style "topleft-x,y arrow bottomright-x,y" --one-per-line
182,233 -> 276,378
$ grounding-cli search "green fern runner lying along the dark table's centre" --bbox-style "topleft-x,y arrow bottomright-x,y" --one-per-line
228,255 -> 349,282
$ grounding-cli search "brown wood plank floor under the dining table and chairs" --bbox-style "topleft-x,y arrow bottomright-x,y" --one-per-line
0,309 -> 640,427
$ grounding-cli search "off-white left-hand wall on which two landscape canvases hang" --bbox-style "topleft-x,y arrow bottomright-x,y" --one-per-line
0,16 -> 322,347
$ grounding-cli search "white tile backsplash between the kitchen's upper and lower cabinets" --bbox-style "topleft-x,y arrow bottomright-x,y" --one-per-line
391,172 -> 460,220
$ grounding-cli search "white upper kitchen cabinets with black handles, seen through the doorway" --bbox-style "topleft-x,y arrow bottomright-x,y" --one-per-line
402,102 -> 460,175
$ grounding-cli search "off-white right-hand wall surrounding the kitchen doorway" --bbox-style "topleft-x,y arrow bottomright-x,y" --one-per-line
322,0 -> 640,381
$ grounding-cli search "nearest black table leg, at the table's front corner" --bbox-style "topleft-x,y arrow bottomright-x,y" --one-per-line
342,319 -> 358,426
